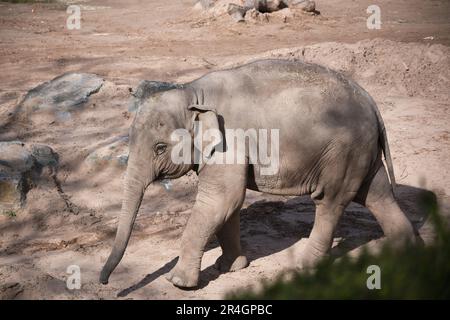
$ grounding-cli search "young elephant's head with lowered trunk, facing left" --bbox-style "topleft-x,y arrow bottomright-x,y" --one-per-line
100,82 -> 218,284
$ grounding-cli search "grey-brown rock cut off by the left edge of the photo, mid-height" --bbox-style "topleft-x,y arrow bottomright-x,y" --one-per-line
0,141 -> 58,213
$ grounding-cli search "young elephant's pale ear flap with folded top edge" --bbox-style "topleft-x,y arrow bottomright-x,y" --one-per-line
188,104 -> 223,173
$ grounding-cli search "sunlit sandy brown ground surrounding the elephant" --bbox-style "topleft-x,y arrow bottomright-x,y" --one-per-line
0,0 -> 450,299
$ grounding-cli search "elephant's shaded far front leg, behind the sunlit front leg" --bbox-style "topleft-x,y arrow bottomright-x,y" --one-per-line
215,209 -> 248,272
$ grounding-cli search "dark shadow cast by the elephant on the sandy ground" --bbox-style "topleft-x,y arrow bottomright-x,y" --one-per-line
118,185 -> 430,297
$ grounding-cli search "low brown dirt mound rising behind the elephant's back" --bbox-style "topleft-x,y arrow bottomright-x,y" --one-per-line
224,39 -> 450,99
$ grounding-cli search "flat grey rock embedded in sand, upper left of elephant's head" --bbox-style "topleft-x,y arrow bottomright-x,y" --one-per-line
20,73 -> 104,121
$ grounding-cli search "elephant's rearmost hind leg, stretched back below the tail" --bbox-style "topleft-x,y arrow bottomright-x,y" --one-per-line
355,164 -> 416,245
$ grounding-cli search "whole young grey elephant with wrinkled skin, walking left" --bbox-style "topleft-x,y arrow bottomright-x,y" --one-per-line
100,60 -> 415,287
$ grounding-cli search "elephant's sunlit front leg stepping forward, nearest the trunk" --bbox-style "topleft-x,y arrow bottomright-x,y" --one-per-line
167,161 -> 246,288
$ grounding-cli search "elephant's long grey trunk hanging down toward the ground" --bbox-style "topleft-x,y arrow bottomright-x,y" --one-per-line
100,159 -> 153,284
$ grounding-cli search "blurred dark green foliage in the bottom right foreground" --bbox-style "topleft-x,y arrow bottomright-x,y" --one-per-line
229,192 -> 450,299
